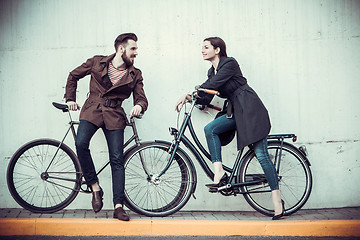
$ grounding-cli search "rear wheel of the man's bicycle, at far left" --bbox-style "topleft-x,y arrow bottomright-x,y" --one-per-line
7,139 -> 82,213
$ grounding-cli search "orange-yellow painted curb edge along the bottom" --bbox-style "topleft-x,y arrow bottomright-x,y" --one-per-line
0,218 -> 360,237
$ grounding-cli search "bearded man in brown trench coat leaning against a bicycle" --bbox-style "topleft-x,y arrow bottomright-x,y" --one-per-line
65,33 -> 148,221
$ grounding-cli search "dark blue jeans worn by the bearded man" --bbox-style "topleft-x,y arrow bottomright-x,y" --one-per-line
75,120 -> 125,206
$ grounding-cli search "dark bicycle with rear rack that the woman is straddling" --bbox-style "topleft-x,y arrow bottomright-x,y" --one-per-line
121,90 -> 312,217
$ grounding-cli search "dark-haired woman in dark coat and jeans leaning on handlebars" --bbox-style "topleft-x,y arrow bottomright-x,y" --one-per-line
176,37 -> 284,220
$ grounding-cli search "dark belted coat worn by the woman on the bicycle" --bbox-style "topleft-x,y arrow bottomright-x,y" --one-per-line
201,57 -> 271,150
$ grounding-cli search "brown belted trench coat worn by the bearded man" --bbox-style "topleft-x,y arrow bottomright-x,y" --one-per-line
64,54 -> 148,130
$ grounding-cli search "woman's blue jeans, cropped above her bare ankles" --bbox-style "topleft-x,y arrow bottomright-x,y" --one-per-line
204,115 -> 279,190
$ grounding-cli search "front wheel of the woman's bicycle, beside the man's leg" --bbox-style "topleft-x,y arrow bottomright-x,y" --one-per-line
124,142 -> 195,217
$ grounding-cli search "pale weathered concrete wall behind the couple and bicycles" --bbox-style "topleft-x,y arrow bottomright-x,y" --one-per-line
0,0 -> 360,210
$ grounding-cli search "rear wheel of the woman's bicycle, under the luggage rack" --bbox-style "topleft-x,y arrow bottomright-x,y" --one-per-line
238,141 -> 312,216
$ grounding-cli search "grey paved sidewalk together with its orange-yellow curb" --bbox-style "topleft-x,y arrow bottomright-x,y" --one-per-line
0,207 -> 360,237
